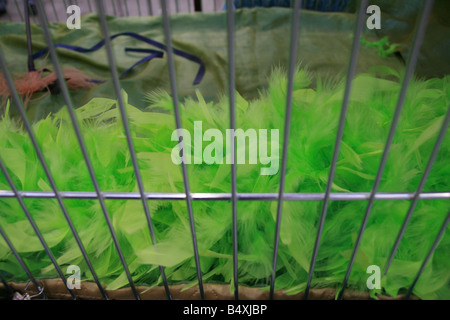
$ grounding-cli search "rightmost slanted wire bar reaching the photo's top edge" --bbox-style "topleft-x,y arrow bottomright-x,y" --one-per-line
338,0 -> 434,300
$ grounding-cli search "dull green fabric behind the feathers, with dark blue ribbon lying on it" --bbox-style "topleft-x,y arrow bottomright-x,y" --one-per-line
0,4 -> 450,119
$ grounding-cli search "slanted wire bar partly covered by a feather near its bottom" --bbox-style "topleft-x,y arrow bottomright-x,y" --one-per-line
97,0 -> 172,300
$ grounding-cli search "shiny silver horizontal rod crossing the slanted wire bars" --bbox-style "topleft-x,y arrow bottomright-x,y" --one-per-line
0,190 -> 450,201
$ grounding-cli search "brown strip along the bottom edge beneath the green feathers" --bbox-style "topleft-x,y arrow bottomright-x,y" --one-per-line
0,279 -> 416,300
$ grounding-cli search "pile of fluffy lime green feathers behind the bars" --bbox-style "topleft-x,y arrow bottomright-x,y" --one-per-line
0,69 -> 450,299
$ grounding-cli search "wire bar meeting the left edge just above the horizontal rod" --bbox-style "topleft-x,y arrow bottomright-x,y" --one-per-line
0,154 -> 77,300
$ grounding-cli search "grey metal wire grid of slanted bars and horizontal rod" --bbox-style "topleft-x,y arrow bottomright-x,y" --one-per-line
0,0 -> 450,299
